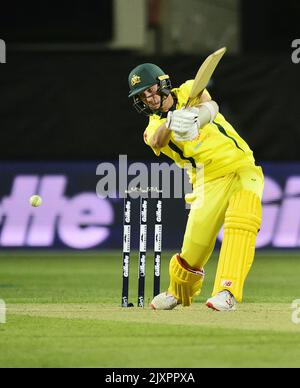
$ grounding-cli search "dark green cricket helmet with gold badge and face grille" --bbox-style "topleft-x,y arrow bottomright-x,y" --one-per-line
128,63 -> 172,116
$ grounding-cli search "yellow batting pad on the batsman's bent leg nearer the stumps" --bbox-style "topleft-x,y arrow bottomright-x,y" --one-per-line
168,255 -> 204,306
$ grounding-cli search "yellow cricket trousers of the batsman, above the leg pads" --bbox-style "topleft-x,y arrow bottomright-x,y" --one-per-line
180,166 -> 264,276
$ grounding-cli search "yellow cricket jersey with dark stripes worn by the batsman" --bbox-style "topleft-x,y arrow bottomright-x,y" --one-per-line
144,80 -> 255,184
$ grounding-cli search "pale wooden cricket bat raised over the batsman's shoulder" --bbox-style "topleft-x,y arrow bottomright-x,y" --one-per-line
186,47 -> 227,107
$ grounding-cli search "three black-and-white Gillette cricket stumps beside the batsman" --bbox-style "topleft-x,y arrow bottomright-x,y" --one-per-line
122,191 -> 162,308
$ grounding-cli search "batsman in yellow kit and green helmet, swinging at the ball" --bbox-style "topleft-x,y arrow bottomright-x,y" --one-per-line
129,63 -> 264,311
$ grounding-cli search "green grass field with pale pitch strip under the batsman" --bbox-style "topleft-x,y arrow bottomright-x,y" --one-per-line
0,252 -> 300,368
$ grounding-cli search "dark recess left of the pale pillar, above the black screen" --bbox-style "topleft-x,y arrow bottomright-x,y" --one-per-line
0,0 -> 113,43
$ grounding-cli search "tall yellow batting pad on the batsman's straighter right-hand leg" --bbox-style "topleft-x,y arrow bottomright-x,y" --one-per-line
213,190 -> 262,302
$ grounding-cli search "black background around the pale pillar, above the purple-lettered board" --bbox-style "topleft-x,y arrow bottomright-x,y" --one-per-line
0,0 -> 300,161
